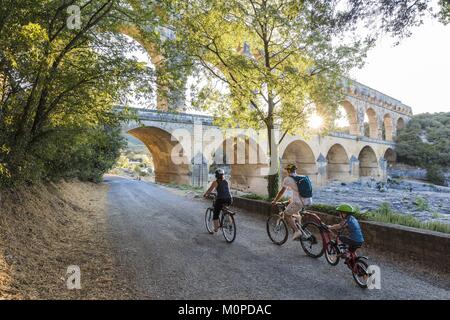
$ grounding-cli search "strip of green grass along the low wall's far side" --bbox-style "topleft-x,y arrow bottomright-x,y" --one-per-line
311,203 -> 450,234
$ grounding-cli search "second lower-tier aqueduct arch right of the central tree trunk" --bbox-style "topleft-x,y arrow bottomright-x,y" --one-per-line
327,144 -> 350,181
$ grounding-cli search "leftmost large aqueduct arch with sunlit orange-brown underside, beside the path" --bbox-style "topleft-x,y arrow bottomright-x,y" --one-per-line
128,127 -> 192,185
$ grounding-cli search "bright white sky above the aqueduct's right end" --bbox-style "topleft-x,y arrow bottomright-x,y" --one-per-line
350,18 -> 450,114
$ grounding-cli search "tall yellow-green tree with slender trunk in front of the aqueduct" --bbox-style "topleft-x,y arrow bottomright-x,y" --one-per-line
168,0 -> 384,196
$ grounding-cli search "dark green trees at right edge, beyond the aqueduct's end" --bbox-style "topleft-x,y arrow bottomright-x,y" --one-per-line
397,112 -> 450,185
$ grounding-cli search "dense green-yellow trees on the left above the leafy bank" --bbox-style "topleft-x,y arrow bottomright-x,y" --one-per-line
0,0 -> 158,186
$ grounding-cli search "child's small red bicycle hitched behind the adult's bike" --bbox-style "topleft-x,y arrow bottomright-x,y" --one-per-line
323,225 -> 371,289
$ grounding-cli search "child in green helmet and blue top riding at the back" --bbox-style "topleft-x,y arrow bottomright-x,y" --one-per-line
328,203 -> 364,252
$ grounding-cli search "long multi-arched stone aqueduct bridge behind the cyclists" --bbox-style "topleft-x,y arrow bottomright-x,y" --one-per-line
123,82 -> 412,194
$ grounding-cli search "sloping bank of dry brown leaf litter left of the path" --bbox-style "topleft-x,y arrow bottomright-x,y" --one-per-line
0,182 -> 133,299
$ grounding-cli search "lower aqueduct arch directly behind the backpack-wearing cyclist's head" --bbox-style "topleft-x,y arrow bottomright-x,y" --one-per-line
281,140 -> 318,183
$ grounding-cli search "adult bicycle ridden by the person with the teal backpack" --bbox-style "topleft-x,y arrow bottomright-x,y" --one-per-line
266,201 -> 325,258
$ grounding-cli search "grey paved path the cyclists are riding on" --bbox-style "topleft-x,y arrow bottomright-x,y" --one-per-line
106,177 -> 450,299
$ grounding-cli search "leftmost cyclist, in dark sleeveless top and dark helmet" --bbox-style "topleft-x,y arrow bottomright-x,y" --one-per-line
203,169 -> 233,234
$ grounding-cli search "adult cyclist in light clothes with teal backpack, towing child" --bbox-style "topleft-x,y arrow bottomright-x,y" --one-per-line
272,164 -> 312,240
